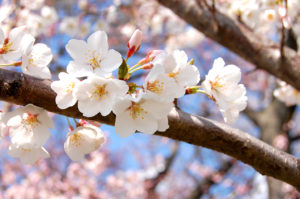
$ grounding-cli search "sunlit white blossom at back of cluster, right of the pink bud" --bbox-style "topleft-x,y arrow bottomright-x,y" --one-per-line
153,50 -> 200,98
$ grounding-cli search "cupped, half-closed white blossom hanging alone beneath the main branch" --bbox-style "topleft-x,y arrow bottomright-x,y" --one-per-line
64,125 -> 104,161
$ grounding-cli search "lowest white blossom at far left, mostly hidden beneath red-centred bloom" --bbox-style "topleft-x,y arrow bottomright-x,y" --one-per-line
8,144 -> 50,164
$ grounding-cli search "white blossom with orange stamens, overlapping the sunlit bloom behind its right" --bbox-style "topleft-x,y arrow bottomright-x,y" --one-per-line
144,64 -> 177,102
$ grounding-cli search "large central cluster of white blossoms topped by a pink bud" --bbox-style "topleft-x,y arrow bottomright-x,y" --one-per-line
51,30 -> 247,137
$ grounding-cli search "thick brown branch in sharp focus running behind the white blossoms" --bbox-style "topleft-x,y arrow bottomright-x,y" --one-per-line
0,69 -> 300,190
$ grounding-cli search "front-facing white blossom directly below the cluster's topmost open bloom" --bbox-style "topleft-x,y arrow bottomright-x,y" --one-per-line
75,75 -> 128,117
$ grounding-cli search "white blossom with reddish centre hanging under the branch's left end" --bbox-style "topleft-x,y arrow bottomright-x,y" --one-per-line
4,104 -> 54,147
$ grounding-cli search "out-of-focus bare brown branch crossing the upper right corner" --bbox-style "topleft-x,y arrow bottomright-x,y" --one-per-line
157,0 -> 300,90
